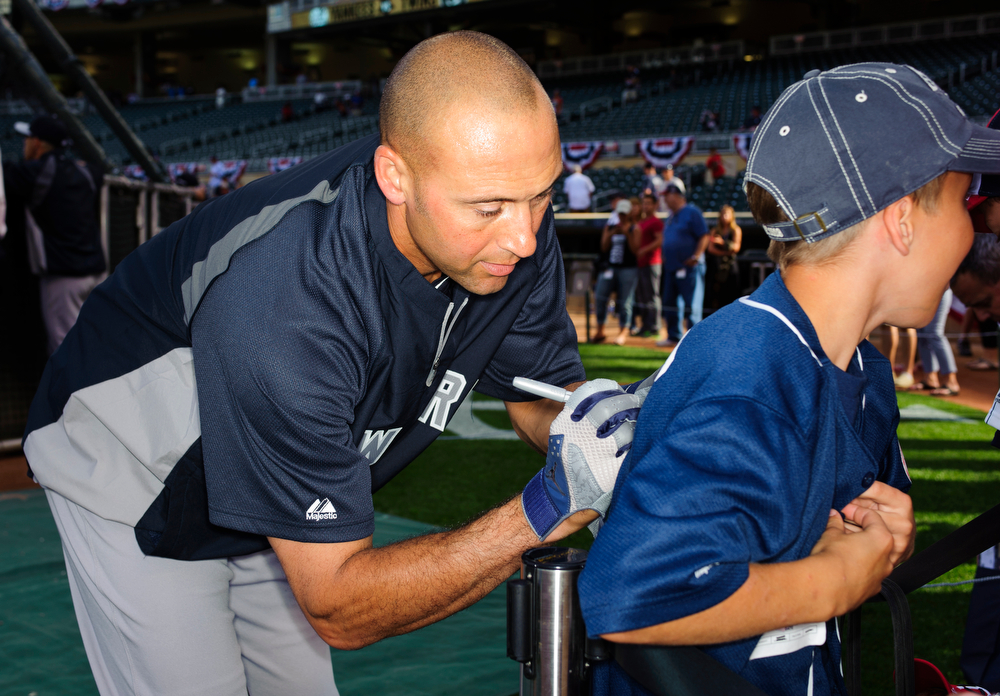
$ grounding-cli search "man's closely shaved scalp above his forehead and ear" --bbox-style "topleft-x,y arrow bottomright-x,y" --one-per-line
379,31 -> 555,165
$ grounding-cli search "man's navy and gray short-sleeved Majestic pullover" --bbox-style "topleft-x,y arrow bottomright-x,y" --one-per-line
25,137 -> 584,559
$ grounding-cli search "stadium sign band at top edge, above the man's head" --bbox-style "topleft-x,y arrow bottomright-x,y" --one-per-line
267,0 -> 482,34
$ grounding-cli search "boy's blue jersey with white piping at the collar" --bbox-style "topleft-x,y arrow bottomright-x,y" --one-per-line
580,273 -> 910,696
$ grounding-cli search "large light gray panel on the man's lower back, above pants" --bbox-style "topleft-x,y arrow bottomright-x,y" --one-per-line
24,348 -> 201,526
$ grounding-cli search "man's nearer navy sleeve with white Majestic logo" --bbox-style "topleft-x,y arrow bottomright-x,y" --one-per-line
192,204 -> 380,542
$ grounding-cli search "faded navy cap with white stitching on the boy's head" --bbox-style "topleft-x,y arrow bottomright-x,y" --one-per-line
746,63 -> 1000,242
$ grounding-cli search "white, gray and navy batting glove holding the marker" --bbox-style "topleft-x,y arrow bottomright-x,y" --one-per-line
521,379 -> 642,540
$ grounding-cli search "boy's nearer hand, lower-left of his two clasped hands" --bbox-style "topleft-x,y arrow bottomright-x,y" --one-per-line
810,506 -> 893,616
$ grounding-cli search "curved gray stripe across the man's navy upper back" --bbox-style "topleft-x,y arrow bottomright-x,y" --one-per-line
181,179 -> 340,325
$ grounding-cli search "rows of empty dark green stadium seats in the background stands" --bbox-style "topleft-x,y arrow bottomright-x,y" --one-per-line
0,36 -> 1000,171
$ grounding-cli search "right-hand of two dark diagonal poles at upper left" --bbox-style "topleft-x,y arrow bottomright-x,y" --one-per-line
8,0 -> 170,183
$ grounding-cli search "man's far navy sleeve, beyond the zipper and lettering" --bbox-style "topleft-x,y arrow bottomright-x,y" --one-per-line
476,208 -> 587,401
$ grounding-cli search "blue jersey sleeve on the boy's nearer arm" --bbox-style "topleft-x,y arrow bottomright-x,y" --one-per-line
580,396 -> 816,635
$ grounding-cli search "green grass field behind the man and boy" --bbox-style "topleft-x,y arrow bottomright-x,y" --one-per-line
375,345 -> 1000,696
